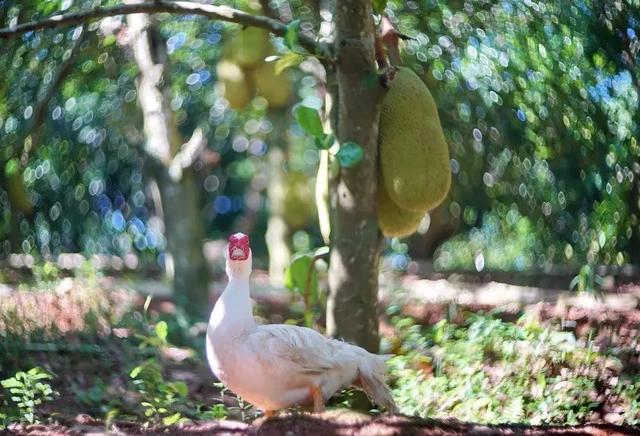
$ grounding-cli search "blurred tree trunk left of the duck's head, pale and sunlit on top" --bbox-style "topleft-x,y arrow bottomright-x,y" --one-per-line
127,8 -> 209,317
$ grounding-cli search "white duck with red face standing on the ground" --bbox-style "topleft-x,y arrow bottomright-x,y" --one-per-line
206,233 -> 395,417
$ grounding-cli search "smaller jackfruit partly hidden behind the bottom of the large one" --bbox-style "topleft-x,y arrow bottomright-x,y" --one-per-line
378,184 -> 427,238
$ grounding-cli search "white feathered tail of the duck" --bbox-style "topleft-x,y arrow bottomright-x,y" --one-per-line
358,353 -> 398,413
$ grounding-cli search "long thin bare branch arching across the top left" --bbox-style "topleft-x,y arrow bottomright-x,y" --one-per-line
0,0 -> 331,58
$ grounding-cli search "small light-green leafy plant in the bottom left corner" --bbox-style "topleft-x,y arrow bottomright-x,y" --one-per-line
0,367 -> 57,424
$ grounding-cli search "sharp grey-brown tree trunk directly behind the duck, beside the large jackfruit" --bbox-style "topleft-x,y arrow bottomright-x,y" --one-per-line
327,0 -> 383,351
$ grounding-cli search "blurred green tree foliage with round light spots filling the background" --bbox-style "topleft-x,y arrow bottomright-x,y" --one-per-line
0,0 -> 640,271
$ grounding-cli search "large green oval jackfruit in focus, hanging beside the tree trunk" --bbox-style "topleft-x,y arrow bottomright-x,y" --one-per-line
379,67 -> 451,213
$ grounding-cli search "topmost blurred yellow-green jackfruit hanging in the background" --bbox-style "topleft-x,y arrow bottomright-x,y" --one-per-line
226,27 -> 273,68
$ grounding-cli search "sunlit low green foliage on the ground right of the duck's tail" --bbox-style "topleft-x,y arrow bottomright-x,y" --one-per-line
390,314 -> 640,424
